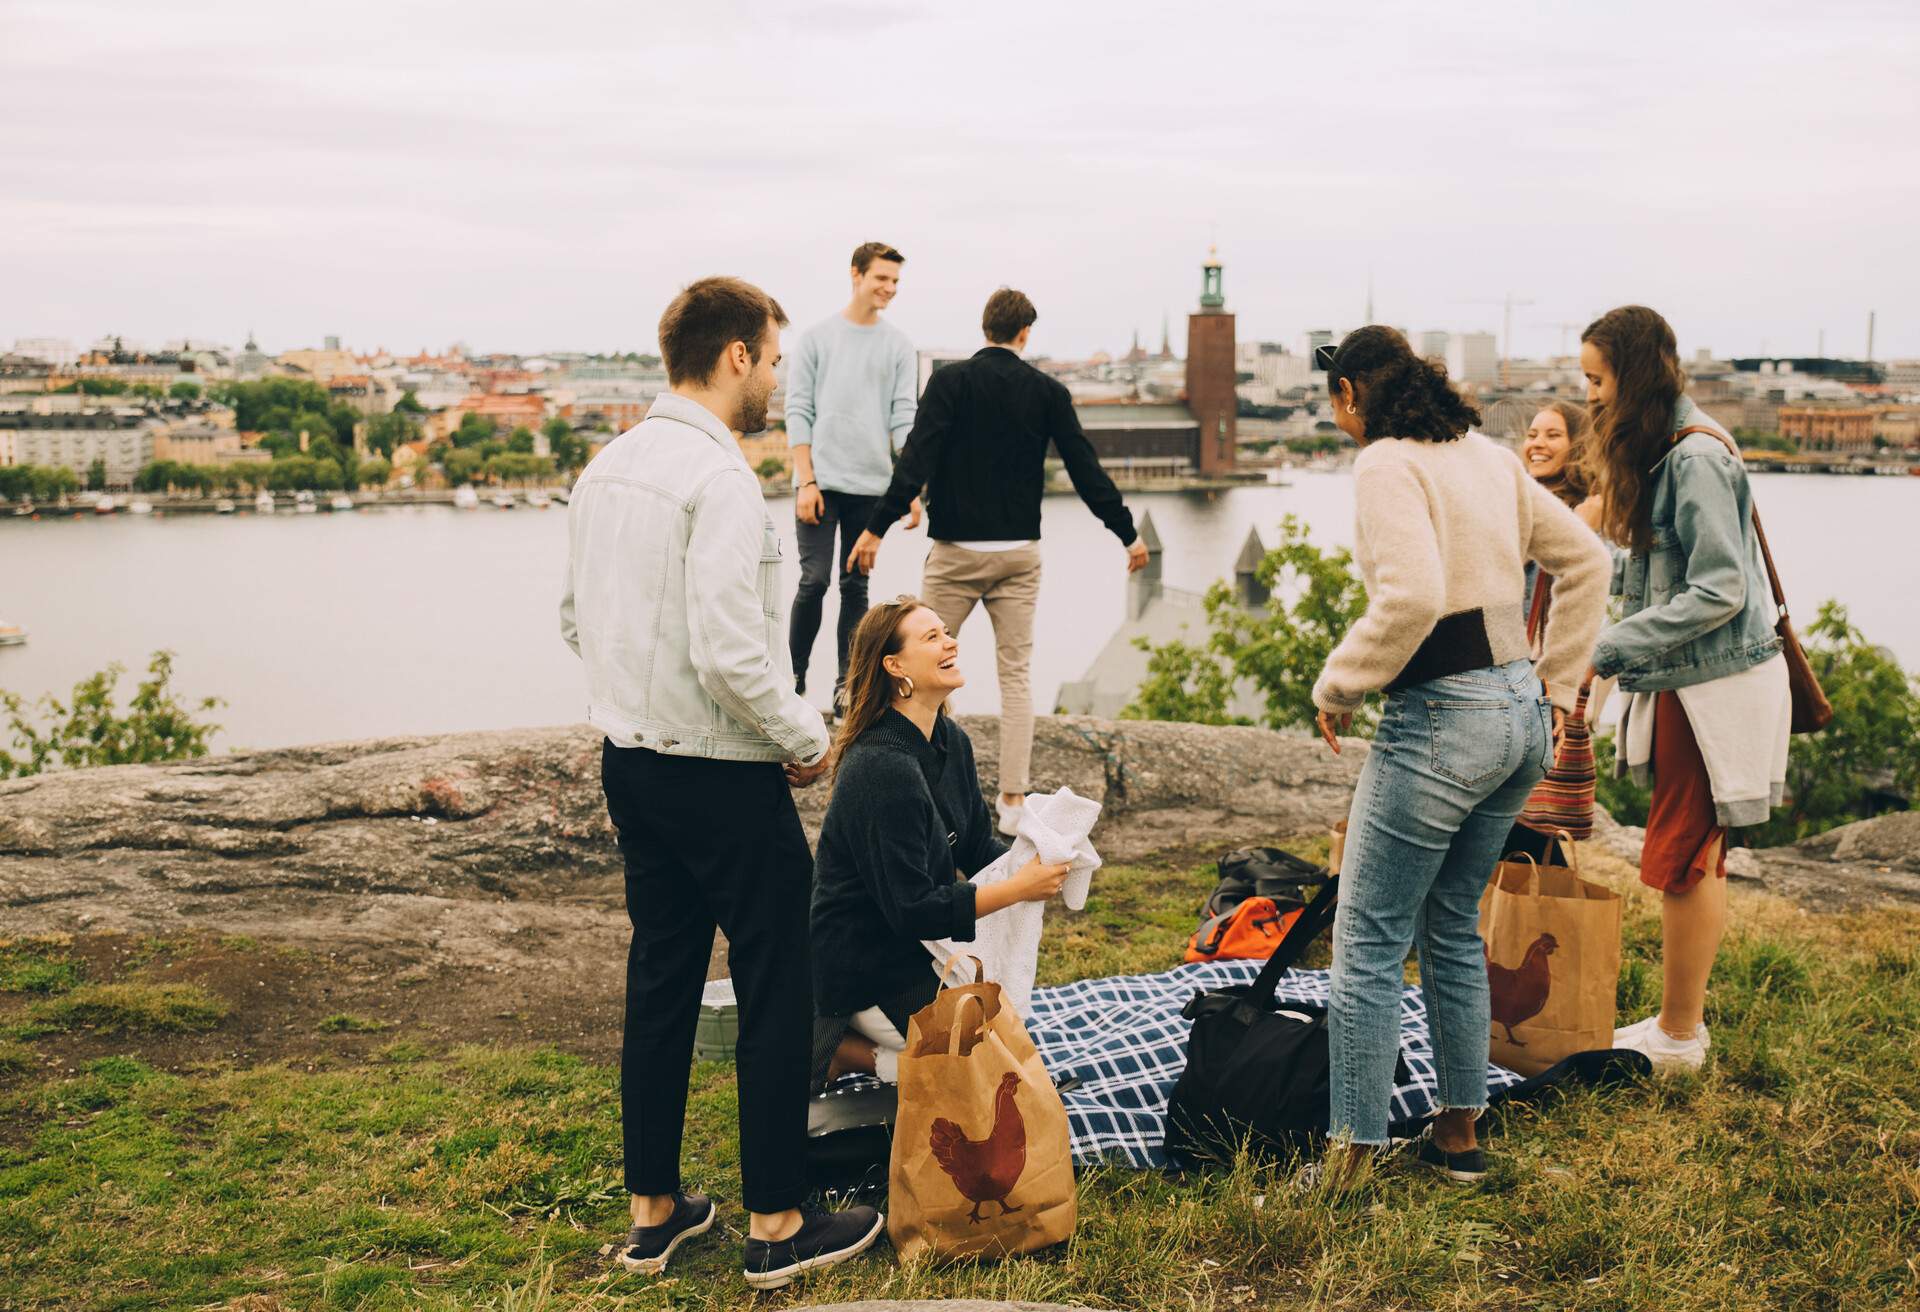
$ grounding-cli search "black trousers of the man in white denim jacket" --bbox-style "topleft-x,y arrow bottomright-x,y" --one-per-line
601,743 -> 814,1212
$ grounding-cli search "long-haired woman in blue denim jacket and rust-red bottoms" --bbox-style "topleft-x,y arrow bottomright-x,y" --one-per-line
1580,305 -> 1791,1072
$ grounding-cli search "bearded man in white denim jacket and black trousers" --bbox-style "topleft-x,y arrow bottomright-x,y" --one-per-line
561,279 -> 885,1289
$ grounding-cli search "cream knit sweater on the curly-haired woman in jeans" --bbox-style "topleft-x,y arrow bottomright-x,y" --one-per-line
1313,432 -> 1613,713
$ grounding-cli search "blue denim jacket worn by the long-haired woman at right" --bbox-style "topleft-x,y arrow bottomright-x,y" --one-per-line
1594,396 -> 1780,692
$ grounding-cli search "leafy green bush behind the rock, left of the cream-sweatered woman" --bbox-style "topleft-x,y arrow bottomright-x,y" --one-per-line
1121,515 -> 1377,730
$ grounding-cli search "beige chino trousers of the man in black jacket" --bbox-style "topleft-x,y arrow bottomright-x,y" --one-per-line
920,542 -> 1041,793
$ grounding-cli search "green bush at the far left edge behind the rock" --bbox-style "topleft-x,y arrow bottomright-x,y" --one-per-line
0,651 -> 223,778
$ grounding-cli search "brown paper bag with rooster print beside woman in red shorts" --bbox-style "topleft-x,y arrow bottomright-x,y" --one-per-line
1480,838 -> 1620,1076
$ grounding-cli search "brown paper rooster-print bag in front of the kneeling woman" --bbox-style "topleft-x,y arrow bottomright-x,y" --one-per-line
887,964 -> 1077,1258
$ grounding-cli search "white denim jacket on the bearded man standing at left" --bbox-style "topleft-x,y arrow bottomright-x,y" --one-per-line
561,392 -> 828,765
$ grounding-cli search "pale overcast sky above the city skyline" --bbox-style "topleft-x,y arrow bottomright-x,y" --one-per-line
0,0 -> 1920,357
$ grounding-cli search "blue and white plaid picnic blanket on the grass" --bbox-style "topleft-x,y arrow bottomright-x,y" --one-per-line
1027,960 -> 1521,1168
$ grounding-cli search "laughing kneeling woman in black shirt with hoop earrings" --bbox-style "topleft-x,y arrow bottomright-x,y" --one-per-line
812,597 -> 1068,1087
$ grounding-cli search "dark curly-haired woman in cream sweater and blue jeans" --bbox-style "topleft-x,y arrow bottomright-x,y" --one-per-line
1313,327 -> 1607,1181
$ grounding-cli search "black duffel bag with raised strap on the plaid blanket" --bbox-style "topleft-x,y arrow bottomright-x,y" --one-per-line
1167,878 -> 1397,1166
